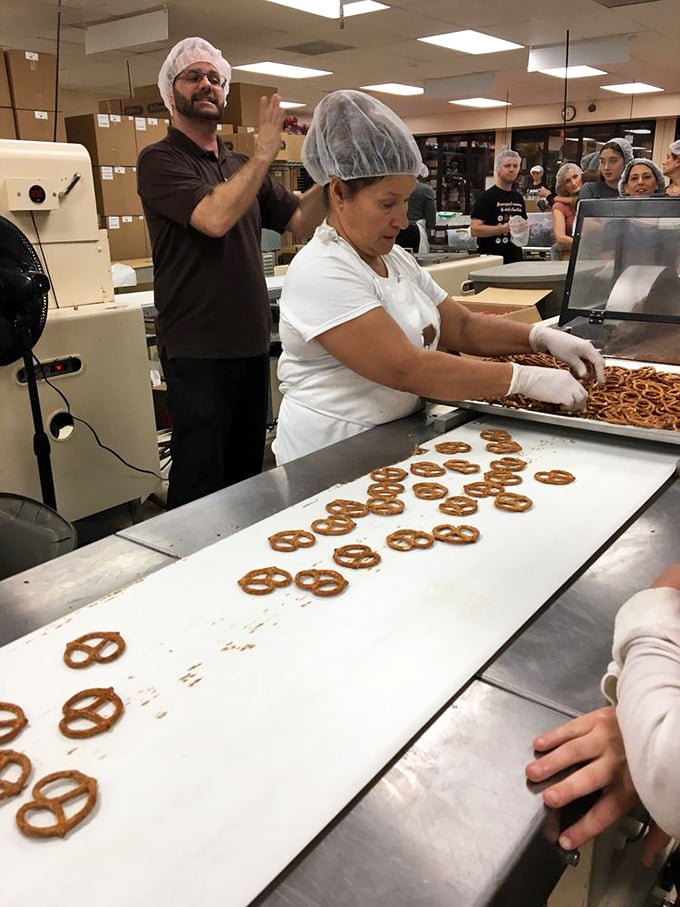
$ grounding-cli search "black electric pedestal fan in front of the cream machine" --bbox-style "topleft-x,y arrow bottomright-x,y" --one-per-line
0,217 -> 56,509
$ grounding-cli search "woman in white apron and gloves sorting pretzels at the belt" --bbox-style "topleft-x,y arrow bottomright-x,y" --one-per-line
273,91 -> 603,464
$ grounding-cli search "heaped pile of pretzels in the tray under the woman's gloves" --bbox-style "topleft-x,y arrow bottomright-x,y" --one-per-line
488,353 -> 680,431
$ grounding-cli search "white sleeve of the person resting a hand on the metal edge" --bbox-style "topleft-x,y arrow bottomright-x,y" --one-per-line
610,588 -> 680,838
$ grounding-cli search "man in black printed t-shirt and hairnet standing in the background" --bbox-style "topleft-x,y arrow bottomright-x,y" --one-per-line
470,151 -> 527,264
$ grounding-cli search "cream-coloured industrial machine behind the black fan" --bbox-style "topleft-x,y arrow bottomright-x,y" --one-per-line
0,140 -> 160,520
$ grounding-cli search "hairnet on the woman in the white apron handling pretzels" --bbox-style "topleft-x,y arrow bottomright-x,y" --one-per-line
302,90 -> 428,186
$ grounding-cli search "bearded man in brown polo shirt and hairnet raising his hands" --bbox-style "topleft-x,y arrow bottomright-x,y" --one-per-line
137,38 -> 325,508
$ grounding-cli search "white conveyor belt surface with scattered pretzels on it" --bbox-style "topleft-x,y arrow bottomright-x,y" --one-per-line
0,419 -> 677,907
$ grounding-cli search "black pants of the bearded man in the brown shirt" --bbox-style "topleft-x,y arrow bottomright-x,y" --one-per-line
161,354 -> 269,509
